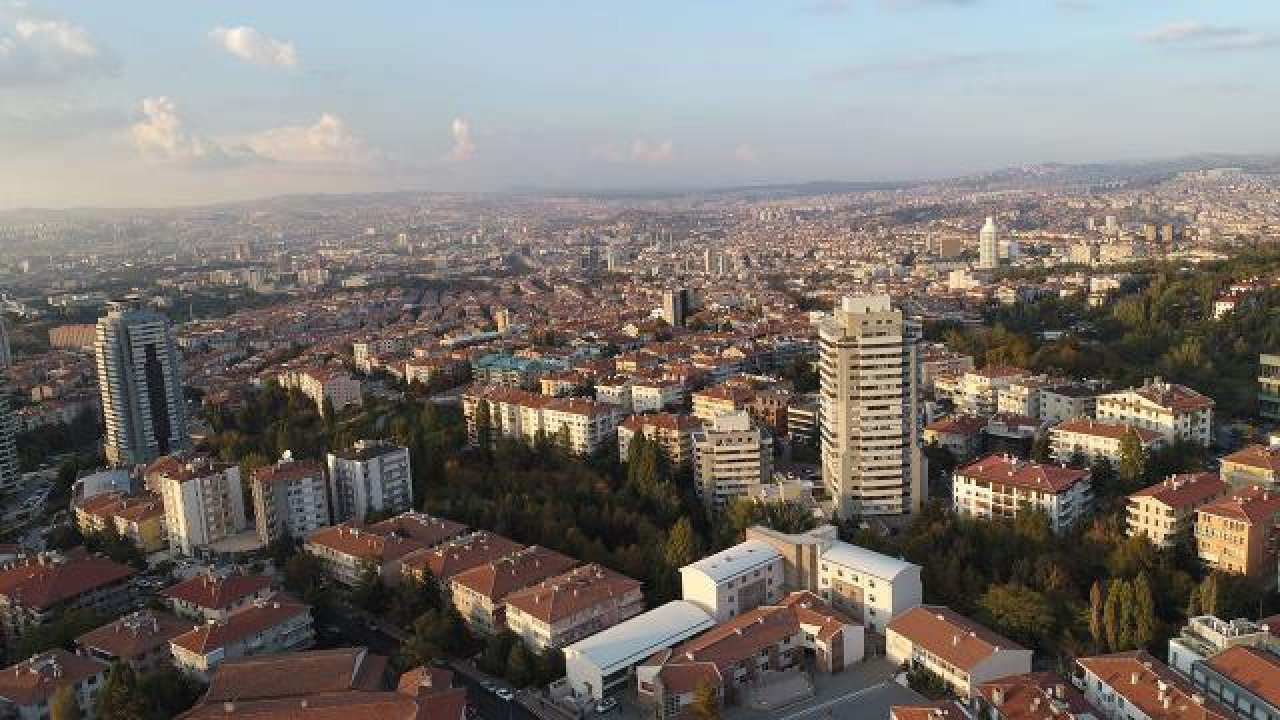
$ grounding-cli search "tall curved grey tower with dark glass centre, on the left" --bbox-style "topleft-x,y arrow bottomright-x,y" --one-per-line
95,299 -> 191,465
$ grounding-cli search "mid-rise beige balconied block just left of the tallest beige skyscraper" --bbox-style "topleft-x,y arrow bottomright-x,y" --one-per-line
692,410 -> 773,509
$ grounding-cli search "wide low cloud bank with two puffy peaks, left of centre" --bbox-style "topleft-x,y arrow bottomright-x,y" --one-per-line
131,97 -> 379,169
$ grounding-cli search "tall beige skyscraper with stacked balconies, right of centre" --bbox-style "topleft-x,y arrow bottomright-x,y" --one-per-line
818,295 -> 925,518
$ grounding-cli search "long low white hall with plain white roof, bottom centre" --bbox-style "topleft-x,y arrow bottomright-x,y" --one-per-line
564,600 -> 716,701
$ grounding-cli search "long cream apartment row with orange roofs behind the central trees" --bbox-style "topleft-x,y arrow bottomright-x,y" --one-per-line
462,386 -> 622,455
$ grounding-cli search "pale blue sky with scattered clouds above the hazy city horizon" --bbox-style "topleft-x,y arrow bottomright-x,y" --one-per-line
0,0 -> 1280,208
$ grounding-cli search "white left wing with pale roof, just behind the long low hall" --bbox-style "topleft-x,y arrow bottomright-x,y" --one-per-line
680,541 -> 785,623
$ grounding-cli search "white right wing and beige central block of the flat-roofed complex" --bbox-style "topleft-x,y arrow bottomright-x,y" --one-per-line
746,517 -> 923,633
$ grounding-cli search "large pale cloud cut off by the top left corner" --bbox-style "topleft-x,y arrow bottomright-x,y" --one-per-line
0,0 -> 119,87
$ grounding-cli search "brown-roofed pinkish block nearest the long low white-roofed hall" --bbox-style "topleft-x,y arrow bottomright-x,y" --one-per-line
507,564 -> 644,652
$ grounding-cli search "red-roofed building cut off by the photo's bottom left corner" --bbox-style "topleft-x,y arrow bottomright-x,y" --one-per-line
0,648 -> 111,720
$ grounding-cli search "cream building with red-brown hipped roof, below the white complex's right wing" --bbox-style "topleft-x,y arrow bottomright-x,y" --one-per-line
884,605 -> 1032,701
